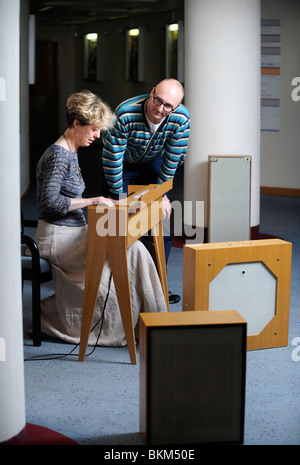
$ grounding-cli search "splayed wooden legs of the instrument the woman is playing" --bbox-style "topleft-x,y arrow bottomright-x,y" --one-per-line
79,206 -> 169,365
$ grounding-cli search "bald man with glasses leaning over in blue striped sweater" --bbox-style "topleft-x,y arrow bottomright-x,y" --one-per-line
102,79 -> 190,303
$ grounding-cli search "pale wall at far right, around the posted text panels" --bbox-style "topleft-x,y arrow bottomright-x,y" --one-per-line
261,0 -> 300,189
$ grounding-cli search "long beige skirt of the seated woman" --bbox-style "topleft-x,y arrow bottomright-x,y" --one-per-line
36,220 -> 166,346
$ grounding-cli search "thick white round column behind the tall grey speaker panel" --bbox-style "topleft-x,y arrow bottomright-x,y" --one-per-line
184,0 -> 260,237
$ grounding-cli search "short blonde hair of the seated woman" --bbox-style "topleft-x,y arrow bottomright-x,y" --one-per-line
66,90 -> 115,131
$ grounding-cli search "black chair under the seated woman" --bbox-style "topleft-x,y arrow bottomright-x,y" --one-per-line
21,211 -> 52,346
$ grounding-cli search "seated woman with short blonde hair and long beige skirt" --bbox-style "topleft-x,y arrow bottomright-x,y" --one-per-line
36,90 -> 166,346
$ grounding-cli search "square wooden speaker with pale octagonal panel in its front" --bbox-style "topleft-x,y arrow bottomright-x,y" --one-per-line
182,239 -> 292,350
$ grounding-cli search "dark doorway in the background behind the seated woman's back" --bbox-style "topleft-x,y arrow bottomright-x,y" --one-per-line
30,41 -> 59,183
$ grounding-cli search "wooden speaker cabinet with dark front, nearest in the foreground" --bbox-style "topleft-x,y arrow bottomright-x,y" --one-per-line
139,311 -> 247,445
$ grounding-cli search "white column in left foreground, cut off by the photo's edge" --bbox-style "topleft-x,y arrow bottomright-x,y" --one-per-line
0,0 -> 26,443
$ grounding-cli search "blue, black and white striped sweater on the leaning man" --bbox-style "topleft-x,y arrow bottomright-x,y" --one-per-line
102,95 -> 190,195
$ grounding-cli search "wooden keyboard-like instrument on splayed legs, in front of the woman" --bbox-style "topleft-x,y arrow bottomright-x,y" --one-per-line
79,179 -> 173,365
